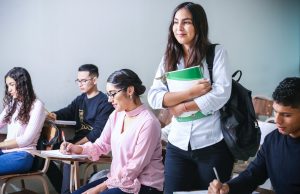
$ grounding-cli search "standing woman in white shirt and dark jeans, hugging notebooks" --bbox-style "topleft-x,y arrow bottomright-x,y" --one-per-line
148,2 -> 234,194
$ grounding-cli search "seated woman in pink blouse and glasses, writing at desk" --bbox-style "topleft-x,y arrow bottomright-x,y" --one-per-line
60,69 -> 164,194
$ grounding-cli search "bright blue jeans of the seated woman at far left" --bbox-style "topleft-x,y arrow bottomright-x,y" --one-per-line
0,150 -> 33,175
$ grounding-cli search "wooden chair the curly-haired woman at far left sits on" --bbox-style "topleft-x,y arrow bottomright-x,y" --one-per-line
0,121 -> 58,194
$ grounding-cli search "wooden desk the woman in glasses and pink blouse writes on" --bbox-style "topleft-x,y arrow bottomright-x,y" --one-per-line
31,150 -> 111,192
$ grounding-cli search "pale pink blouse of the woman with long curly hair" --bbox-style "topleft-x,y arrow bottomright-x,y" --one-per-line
0,99 -> 46,152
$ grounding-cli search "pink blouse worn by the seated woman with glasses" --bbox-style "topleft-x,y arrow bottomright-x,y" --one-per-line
82,105 -> 164,193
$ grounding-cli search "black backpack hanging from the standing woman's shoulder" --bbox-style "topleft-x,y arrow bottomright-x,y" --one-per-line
206,44 -> 261,160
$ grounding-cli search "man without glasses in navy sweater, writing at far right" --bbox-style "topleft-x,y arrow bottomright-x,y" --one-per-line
208,77 -> 300,194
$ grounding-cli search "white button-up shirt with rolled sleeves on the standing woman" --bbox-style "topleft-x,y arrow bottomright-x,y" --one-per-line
148,45 -> 232,150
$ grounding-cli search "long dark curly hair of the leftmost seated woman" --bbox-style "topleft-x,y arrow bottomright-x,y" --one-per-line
3,67 -> 36,124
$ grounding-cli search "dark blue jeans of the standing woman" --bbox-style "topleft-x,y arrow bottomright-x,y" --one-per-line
164,140 -> 234,194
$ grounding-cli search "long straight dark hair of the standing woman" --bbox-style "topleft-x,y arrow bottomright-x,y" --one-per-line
164,2 -> 210,71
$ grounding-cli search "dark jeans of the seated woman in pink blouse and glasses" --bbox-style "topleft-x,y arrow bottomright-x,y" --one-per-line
72,178 -> 163,194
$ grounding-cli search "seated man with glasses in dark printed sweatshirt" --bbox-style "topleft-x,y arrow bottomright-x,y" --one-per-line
47,64 -> 113,194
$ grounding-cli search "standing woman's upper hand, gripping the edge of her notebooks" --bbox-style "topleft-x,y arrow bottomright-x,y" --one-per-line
188,79 -> 211,99
